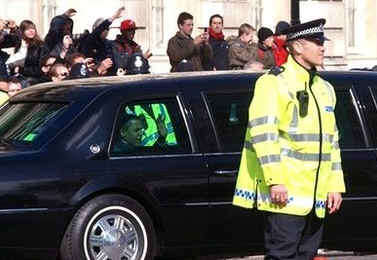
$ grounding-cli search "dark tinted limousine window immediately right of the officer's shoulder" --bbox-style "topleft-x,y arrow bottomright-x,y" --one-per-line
335,90 -> 365,148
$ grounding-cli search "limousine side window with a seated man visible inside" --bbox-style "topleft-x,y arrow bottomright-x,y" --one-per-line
111,99 -> 191,156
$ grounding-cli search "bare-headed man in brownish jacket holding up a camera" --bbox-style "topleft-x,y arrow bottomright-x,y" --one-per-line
167,12 -> 213,72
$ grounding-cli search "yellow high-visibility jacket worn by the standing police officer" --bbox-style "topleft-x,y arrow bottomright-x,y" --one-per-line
233,56 -> 345,218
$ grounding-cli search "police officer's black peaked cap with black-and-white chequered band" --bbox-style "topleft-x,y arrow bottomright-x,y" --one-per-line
282,19 -> 329,43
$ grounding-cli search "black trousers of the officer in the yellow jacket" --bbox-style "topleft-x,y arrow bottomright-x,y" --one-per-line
264,211 -> 323,260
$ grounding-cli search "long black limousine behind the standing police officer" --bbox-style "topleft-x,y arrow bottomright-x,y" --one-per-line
0,71 -> 377,260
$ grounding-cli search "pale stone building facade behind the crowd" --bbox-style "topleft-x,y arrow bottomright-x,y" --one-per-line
0,0 -> 377,72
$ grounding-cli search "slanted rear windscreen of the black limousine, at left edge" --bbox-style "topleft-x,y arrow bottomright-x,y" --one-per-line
0,103 -> 66,143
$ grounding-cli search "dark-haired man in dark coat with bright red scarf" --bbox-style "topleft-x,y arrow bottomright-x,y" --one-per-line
204,14 -> 229,70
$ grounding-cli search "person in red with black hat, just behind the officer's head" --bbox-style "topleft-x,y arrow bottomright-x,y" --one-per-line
273,21 -> 290,66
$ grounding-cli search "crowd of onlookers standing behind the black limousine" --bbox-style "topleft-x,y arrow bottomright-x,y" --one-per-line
0,7 -> 289,99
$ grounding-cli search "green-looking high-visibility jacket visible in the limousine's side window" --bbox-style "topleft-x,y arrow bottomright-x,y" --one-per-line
134,104 -> 177,146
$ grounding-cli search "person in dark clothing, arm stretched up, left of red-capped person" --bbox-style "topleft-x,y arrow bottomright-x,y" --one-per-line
79,7 -> 124,64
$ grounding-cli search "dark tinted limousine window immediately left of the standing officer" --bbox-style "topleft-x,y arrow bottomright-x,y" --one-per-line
207,93 -> 251,152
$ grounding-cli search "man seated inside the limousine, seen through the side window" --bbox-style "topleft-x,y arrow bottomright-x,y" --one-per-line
114,115 -> 170,153
